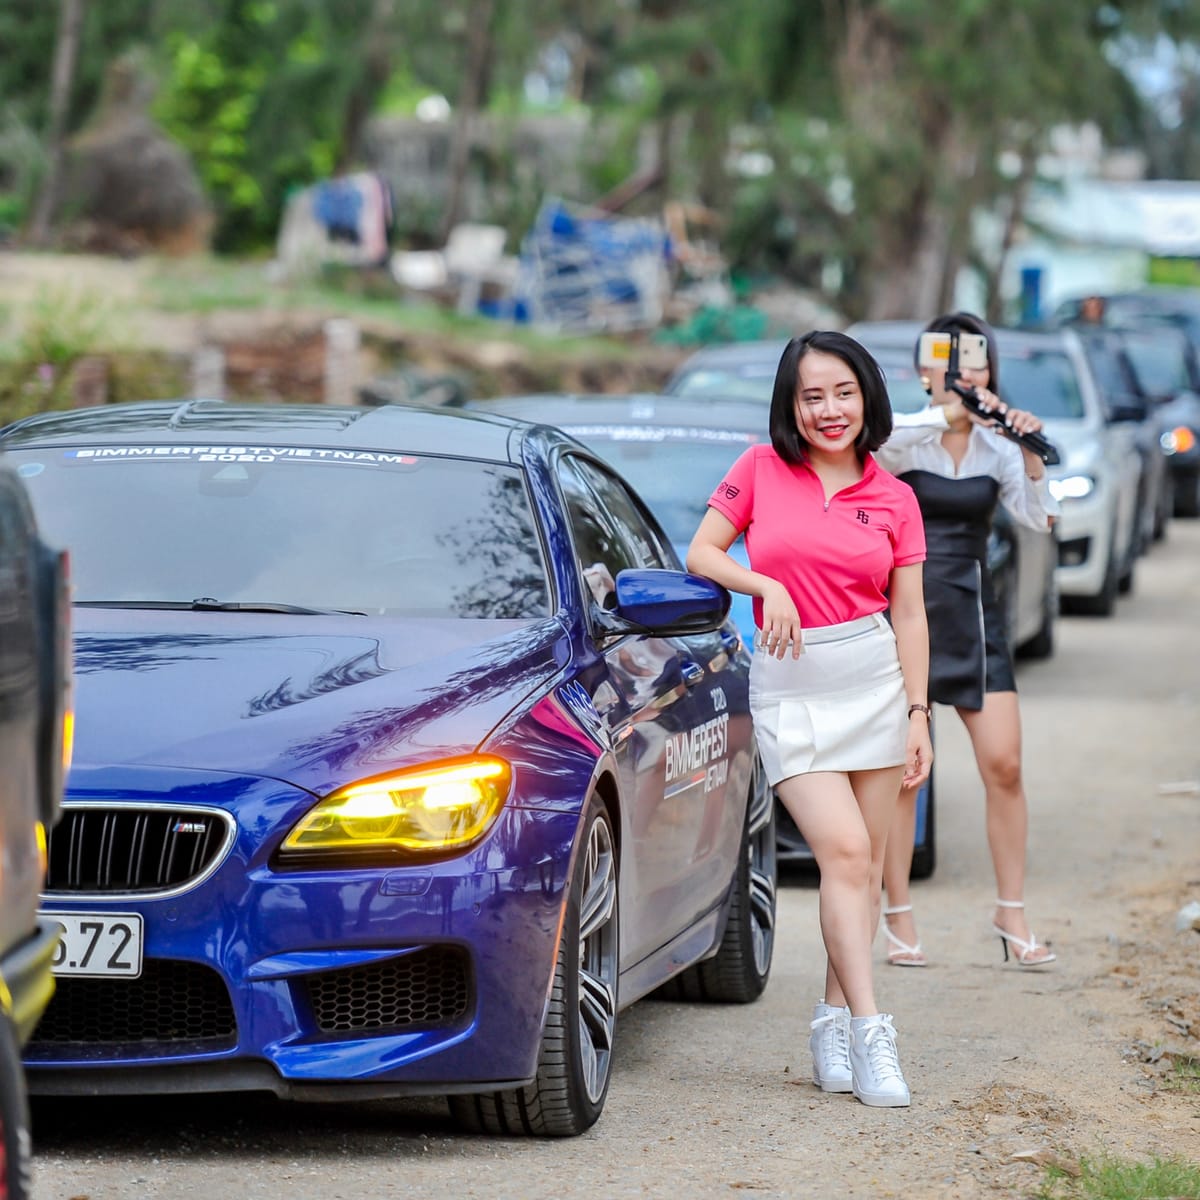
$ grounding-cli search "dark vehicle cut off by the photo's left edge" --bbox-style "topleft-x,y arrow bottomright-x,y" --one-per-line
0,457 -> 71,1200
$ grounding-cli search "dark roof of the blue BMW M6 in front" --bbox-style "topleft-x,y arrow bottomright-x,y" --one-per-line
0,400 -> 535,462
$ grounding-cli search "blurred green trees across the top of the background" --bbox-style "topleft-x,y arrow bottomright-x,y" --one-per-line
0,0 -> 1200,355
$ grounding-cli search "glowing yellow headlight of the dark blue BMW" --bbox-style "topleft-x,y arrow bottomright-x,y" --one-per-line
281,757 -> 512,854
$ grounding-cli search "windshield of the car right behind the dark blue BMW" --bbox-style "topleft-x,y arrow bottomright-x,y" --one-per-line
560,424 -> 753,544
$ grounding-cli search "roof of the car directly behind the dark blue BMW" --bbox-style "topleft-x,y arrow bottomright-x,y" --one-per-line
468,392 -> 769,434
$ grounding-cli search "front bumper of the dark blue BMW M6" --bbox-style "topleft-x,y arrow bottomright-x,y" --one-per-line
26,808 -> 578,1098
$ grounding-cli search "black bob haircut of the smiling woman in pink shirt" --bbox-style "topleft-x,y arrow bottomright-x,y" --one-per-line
770,329 -> 892,464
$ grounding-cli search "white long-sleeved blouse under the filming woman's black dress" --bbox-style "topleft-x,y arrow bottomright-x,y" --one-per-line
875,404 -> 1060,533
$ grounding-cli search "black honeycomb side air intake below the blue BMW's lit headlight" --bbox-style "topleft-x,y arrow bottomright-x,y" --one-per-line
306,946 -> 470,1033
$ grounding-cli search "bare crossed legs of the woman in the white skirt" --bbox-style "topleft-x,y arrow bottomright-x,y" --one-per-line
776,767 -> 902,1016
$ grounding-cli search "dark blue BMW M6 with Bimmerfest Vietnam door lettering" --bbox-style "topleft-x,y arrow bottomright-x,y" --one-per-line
0,402 -> 776,1135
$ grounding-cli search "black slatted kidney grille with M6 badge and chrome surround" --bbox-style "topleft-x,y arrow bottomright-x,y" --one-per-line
46,804 -> 232,893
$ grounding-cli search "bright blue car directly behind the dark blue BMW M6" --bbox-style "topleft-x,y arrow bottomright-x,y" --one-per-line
458,394 -> 936,878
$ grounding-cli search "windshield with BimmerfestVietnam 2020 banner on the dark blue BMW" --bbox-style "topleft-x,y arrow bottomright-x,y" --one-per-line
7,445 -> 550,618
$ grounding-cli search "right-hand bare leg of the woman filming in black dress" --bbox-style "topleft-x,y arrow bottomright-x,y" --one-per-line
959,691 -> 1051,960
